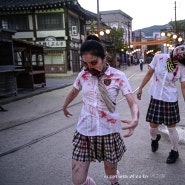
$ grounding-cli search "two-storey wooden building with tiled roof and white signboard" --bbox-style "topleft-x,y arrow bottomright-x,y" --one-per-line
0,0 -> 97,75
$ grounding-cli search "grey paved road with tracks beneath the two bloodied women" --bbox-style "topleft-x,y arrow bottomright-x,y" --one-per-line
0,66 -> 185,185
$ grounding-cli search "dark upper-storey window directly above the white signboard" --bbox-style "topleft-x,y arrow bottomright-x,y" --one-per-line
37,13 -> 64,30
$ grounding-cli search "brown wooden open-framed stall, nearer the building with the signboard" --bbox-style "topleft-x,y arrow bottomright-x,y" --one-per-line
13,39 -> 46,90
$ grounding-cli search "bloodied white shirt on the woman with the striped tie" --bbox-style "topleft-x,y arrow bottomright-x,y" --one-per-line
149,54 -> 185,102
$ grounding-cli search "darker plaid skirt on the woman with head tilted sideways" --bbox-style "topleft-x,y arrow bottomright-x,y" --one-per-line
146,97 -> 180,125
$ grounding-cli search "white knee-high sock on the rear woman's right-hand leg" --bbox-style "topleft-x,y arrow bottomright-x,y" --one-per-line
168,127 -> 179,151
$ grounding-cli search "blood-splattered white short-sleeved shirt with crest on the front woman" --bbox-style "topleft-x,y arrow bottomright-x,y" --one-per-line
74,66 -> 132,136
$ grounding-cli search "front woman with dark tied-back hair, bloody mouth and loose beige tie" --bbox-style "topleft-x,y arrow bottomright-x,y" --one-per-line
63,40 -> 139,185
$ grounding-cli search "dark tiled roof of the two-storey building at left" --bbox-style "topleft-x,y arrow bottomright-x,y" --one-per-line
0,0 -> 97,19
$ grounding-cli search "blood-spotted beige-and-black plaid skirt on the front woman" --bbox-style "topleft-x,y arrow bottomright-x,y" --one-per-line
72,131 -> 126,164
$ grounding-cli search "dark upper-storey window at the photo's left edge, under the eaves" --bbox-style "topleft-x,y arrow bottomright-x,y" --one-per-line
0,15 -> 29,31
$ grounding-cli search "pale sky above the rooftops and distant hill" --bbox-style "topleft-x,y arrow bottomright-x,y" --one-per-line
78,0 -> 185,31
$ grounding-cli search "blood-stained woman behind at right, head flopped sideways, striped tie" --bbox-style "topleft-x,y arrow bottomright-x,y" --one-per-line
137,45 -> 185,164
